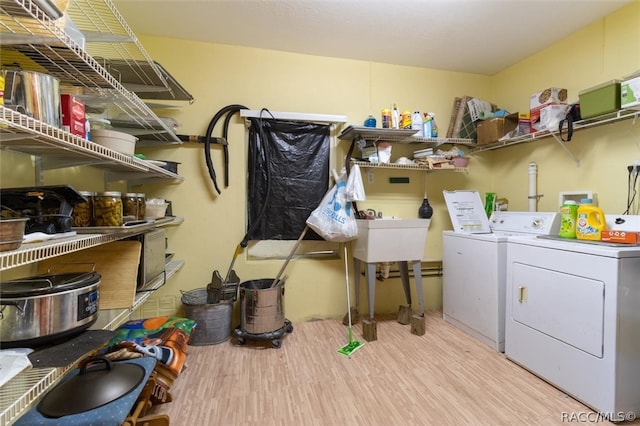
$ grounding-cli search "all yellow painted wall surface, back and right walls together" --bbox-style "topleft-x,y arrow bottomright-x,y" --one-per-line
0,2 -> 640,322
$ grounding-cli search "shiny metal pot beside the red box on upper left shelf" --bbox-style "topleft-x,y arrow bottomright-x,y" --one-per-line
2,69 -> 61,127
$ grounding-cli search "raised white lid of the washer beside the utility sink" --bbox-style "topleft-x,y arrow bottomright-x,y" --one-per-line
442,191 -> 491,234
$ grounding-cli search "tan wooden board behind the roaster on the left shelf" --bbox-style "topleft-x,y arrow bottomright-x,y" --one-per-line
38,241 -> 142,309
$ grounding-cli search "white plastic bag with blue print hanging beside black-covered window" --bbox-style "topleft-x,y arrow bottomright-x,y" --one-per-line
307,174 -> 358,243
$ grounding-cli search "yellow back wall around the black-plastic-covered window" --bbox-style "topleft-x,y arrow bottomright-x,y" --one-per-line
130,35 -> 490,321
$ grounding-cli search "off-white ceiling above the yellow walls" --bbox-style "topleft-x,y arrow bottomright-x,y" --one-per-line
114,0 -> 640,75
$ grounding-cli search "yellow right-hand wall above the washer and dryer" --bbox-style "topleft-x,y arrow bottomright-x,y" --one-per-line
484,2 -> 640,214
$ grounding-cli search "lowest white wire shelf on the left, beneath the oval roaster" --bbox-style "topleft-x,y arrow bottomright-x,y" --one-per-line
0,261 -> 184,425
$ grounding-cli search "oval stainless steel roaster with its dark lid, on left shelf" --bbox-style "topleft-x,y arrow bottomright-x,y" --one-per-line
0,271 -> 102,347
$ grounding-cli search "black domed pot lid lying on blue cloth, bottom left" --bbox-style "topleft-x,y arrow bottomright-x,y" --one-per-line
37,357 -> 145,418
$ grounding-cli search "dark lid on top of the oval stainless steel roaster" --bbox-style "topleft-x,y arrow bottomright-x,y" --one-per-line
0,272 -> 102,299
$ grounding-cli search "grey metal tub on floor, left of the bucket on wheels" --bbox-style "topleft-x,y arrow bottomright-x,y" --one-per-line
182,289 -> 233,346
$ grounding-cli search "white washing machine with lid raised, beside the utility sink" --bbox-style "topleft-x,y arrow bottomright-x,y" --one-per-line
442,191 -> 560,352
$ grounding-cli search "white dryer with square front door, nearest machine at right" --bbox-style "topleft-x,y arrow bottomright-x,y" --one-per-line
505,215 -> 640,421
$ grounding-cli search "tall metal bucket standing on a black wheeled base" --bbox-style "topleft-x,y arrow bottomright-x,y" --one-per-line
240,278 -> 285,334
